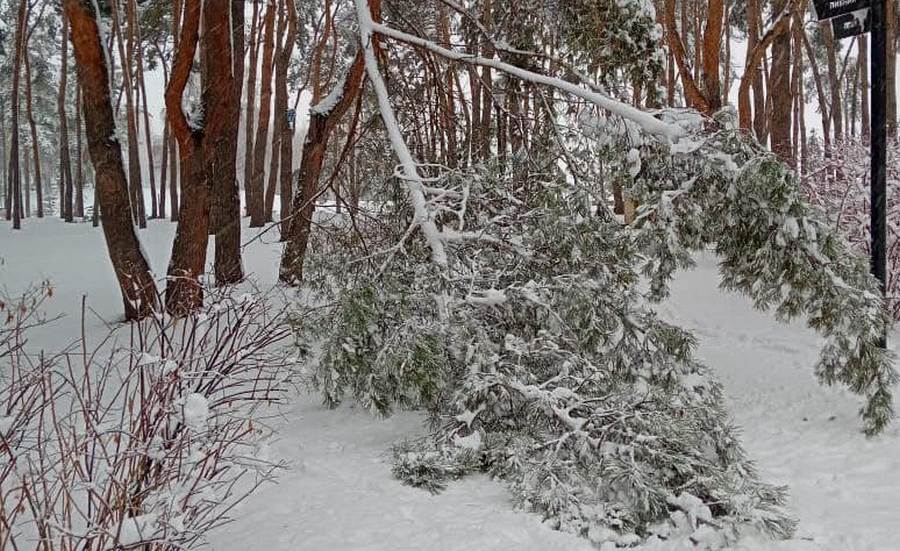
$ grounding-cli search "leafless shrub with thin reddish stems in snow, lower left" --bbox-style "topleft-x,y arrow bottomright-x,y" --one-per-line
0,290 -> 288,551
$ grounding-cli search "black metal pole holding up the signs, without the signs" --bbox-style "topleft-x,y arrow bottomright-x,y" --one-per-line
869,0 -> 887,346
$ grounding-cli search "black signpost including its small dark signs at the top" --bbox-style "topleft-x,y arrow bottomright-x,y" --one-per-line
813,0 -> 887,347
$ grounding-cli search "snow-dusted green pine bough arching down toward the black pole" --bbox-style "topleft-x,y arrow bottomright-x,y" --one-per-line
625,112 -> 897,435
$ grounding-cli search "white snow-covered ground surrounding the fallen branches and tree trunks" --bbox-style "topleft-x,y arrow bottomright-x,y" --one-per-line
0,219 -> 900,551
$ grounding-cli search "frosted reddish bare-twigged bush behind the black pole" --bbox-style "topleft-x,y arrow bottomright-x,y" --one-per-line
800,138 -> 900,320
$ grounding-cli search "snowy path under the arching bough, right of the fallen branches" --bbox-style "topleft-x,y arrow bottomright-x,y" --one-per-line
662,255 -> 900,551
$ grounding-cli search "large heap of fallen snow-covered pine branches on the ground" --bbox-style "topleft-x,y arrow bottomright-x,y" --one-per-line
295,152 -> 793,547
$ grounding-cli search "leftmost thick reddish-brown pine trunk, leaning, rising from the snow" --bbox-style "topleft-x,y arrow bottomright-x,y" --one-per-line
63,0 -> 157,319
